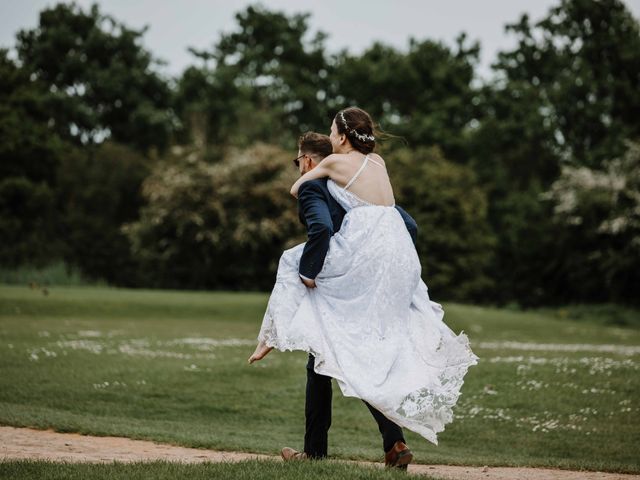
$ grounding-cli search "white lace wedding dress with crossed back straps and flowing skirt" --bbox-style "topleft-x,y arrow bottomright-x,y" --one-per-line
258,157 -> 478,444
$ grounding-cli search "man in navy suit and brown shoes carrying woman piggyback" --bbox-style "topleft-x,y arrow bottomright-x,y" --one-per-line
281,132 -> 418,468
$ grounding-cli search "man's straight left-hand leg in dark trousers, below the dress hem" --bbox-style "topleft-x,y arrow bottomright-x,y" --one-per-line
304,354 -> 331,458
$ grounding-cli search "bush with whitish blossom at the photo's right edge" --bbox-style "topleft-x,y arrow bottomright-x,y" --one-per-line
548,142 -> 640,303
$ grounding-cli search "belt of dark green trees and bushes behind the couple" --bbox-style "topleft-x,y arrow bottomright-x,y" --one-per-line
0,0 -> 640,306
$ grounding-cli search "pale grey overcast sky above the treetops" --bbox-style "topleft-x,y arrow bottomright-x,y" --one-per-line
0,0 -> 640,78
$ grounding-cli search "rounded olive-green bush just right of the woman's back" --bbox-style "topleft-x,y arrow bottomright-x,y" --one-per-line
387,147 -> 495,301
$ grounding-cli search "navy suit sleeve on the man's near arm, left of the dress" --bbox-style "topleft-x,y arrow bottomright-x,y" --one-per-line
298,182 -> 333,279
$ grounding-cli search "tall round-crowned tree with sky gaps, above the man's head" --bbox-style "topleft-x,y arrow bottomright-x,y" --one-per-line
176,6 -> 329,147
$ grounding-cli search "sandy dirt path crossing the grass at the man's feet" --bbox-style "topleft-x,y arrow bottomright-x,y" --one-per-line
0,426 -> 640,480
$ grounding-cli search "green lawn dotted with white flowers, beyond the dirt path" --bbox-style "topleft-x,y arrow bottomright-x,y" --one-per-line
0,285 -> 640,472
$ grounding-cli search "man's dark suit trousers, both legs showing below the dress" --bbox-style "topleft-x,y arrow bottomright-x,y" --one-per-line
304,354 -> 405,458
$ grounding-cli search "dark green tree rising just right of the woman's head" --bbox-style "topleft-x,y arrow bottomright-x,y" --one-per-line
332,34 -> 479,163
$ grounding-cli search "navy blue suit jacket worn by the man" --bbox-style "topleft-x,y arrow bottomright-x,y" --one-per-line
298,178 -> 418,279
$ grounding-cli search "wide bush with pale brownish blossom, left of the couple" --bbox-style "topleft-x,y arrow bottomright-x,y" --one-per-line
124,145 -> 304,289
